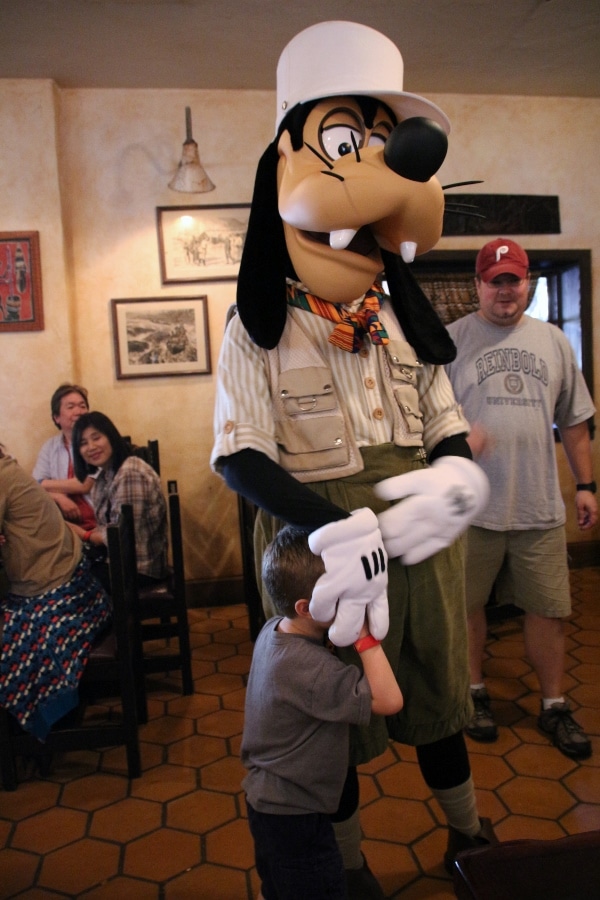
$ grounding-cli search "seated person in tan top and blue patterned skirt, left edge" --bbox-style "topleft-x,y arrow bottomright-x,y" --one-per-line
0,445 -> 111,741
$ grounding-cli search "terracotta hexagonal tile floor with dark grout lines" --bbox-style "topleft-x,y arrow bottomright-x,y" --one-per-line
0,568 -> 600,900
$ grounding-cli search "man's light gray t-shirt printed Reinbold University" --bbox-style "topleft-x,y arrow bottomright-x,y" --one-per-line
446,313 -> 594,531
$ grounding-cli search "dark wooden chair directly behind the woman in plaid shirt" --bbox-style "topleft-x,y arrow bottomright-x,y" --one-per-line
138,481 -> 194,694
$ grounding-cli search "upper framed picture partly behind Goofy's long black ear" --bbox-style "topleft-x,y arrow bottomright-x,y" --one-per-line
156,203 -> 250,284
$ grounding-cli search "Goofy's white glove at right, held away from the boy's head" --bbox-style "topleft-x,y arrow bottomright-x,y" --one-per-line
374,456 -> 490,566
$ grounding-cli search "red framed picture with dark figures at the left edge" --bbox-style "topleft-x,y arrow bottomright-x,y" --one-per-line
0,231 -> 44,331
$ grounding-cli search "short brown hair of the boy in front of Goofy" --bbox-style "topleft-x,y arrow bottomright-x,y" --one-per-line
262,525 -> 325,619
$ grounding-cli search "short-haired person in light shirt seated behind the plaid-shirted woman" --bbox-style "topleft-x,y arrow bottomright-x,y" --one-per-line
33,384 -> 96,531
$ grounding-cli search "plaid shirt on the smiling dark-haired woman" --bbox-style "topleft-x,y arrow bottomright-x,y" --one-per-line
92,456 -> 167,578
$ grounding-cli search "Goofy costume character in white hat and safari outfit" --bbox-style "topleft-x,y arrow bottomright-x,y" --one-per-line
211,21 -> 496,900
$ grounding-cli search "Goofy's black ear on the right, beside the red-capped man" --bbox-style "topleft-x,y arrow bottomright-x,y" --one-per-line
381,250 -> 456,366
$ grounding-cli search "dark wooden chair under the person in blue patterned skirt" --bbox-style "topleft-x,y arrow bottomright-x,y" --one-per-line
0,506 -> 147,791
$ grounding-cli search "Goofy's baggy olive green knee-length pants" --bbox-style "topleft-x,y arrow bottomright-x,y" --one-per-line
254,444 -> 471,765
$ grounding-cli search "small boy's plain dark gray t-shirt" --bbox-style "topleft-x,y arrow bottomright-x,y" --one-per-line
241,616 -> 371,815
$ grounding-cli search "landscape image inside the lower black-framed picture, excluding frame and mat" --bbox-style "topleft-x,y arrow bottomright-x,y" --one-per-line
125,308 -> 198,366
